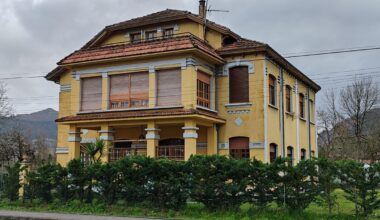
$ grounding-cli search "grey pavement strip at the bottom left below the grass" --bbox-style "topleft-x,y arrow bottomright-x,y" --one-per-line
0,210 -> 157,220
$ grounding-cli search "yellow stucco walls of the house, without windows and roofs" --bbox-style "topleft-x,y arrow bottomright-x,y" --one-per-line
49,9 -> 317,165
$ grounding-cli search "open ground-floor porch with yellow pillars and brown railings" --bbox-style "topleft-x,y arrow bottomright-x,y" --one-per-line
69,120 -> 217,162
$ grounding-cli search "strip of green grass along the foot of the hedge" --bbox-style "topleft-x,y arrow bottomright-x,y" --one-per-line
0,190 -> 380,220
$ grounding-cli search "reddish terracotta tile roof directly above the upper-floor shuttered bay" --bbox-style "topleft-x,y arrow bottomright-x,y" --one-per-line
58,35 -> 223,65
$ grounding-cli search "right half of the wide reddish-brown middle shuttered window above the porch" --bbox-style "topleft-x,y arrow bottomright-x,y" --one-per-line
131,72 -> 149,107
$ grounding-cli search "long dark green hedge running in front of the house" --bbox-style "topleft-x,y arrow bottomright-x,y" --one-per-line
0,155 -> 380,216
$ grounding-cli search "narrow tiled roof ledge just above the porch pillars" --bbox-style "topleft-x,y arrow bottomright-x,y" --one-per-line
56,108 -> 224,122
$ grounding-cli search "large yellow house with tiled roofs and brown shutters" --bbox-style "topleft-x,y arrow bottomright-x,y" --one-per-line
46,0 -> 320,165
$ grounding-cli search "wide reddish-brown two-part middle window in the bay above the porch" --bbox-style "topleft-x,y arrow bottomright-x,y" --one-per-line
110,72 -> 149,109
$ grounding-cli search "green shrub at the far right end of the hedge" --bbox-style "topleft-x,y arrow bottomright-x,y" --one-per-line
338,161 -> 380,217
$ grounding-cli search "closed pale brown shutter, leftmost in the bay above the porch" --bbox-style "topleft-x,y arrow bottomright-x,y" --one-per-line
81,77 -> 102,111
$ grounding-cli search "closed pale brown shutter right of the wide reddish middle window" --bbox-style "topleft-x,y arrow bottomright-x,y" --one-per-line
157,69 -> 181,106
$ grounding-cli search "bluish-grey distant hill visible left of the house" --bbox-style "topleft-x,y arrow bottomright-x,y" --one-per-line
0,108 -> 58,142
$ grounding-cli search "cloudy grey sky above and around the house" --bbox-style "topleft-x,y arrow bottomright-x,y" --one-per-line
0,0 -> 380,114
